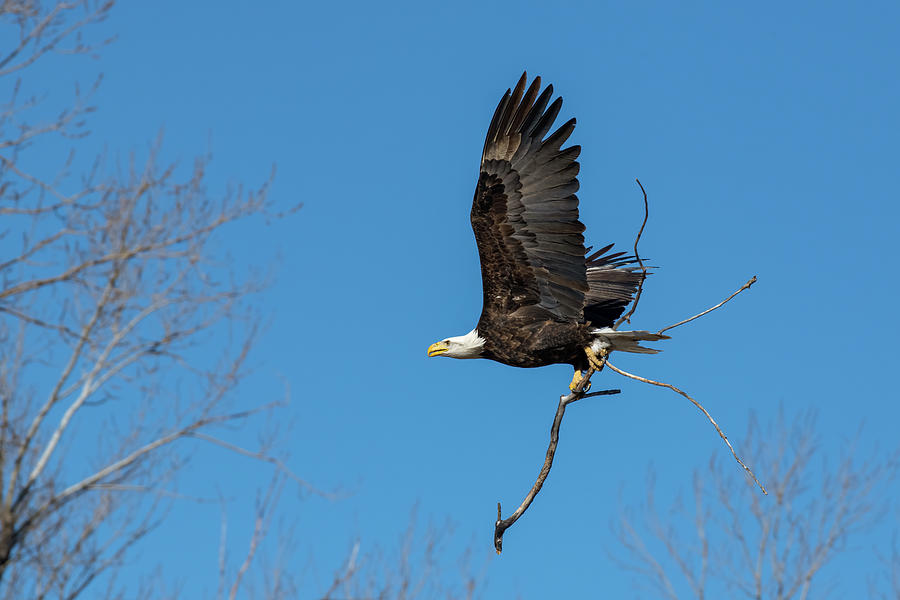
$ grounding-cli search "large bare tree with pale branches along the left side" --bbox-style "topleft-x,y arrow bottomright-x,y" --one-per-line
0,0 -> 304,599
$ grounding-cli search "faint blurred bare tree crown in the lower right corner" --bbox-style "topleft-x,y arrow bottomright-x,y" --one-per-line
612,414 -> 898,600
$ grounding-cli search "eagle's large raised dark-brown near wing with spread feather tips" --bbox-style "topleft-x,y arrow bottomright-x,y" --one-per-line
471,73 -> 590,322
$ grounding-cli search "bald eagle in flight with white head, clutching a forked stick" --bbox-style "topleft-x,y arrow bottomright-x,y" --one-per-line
428,73 -> 668,390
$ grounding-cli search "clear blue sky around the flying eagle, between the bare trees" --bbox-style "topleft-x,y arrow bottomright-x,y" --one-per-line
22,1 -> 900,598
